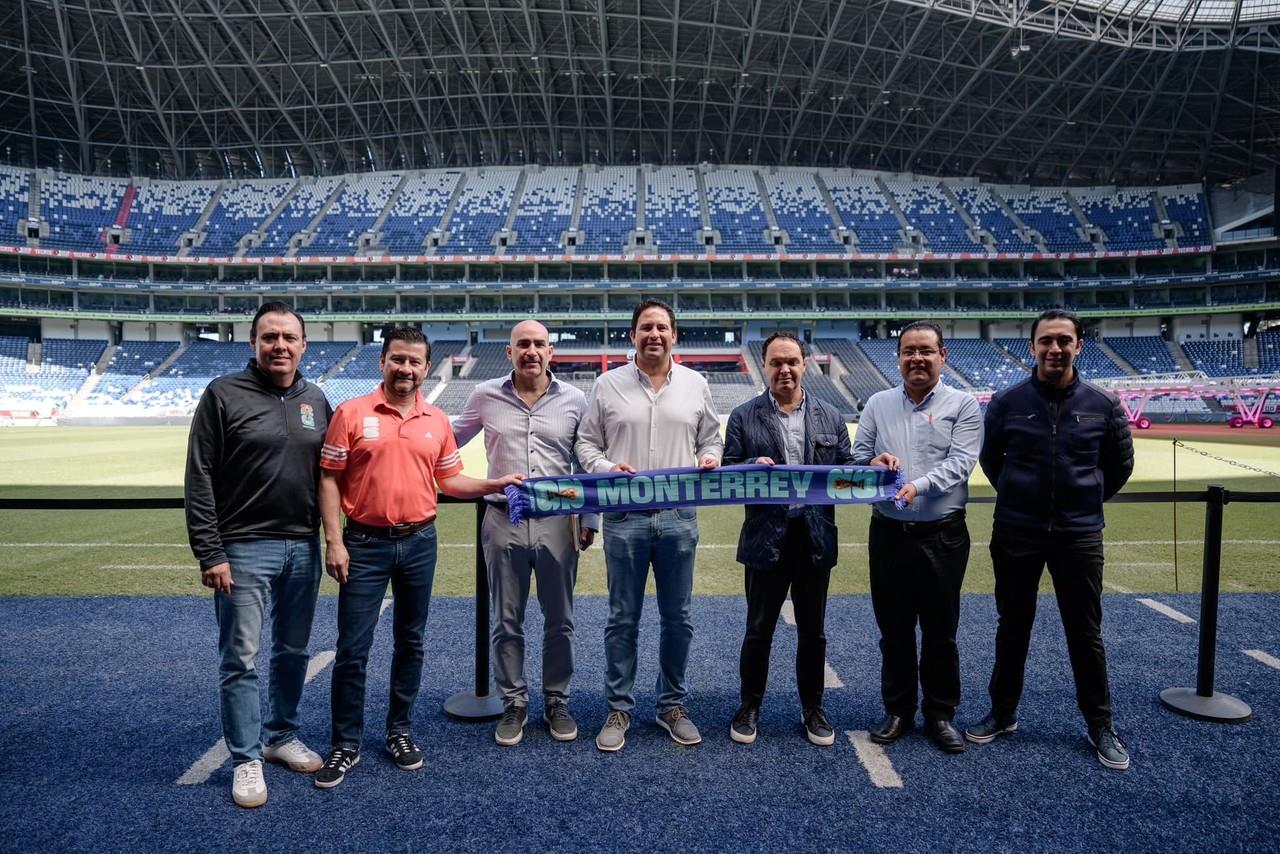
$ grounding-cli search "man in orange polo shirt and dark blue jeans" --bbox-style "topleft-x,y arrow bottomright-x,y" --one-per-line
315,326 -> 522,789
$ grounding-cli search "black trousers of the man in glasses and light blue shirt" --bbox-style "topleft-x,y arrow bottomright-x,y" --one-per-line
868,511 -> 969,721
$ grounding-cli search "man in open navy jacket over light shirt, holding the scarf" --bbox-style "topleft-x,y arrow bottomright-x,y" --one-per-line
722,333 -> 852,745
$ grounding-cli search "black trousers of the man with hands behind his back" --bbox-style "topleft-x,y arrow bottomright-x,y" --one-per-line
988,525 -> 1111,727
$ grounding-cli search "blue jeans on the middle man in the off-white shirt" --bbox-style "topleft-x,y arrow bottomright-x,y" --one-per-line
604,508 -> 698,713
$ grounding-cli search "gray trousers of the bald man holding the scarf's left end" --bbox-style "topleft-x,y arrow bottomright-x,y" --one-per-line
480,504 -> 577,705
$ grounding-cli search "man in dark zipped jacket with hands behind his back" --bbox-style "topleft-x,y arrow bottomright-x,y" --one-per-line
965,309 -> 1133,769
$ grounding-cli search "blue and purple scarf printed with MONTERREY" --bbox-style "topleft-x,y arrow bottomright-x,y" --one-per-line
506,465 -> 904,525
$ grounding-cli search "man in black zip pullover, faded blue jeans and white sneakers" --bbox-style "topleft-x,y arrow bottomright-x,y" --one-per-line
186,302 -> 332,807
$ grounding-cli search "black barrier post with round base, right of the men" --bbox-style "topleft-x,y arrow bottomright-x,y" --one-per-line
1160,485 -> 1253,723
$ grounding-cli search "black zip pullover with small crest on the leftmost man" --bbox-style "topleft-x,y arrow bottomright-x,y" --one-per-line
186,361 -> 333,570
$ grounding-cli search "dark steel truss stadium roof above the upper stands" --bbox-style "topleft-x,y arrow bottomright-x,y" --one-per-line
0,0 -> 1280,184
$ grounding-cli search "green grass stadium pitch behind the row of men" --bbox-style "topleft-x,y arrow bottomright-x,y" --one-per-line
0,428 -> 1280,595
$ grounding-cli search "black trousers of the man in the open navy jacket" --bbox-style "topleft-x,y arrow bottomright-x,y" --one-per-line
737,517 -> 831,709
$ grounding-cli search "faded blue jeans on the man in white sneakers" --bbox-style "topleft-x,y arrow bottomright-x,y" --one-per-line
214,536 -> 321,764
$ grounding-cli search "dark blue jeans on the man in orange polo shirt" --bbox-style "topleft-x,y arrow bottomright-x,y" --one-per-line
332,525 -> 436,750
